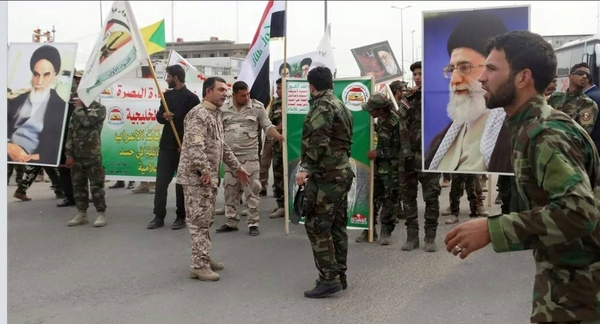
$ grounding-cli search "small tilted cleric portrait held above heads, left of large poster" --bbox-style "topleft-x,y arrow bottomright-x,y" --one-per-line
351,41 -> 402,83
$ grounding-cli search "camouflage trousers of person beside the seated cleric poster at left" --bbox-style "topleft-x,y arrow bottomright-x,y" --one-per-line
71,156 -> 106,213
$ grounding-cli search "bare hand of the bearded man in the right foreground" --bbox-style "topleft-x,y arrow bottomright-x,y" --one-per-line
444,218 -> 492,259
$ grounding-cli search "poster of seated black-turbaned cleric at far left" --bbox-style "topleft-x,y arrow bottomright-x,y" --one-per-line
6,43 -> 77,166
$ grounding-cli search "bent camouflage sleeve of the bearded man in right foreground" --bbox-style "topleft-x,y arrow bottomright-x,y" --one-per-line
488,129 -> 599,252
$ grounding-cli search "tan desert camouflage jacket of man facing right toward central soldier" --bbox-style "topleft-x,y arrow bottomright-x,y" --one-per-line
177,101 -> 240,188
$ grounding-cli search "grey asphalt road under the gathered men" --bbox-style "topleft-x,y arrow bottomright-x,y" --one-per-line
7,175 -> 534,324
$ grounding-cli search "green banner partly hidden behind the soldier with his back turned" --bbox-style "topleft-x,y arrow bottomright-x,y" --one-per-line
283,77 -> 373,230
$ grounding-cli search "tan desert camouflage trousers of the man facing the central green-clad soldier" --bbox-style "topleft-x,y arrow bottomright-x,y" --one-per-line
183,186 -> 218,269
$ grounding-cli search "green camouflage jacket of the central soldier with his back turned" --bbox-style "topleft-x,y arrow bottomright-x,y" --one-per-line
300,90 -> 353,174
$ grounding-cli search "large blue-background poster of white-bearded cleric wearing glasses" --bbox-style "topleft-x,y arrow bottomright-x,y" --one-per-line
422,6 -> 530,175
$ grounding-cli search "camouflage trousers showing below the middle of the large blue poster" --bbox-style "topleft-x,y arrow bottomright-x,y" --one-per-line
450,173 -> 483,216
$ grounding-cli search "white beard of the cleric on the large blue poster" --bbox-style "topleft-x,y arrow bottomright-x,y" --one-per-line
446,81 -> 487,124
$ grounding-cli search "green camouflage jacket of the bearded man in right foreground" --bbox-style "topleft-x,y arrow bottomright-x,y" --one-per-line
488,95 -> 600,323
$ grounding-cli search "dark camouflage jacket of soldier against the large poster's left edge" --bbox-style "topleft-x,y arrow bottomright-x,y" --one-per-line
398,90 -> 422,171
